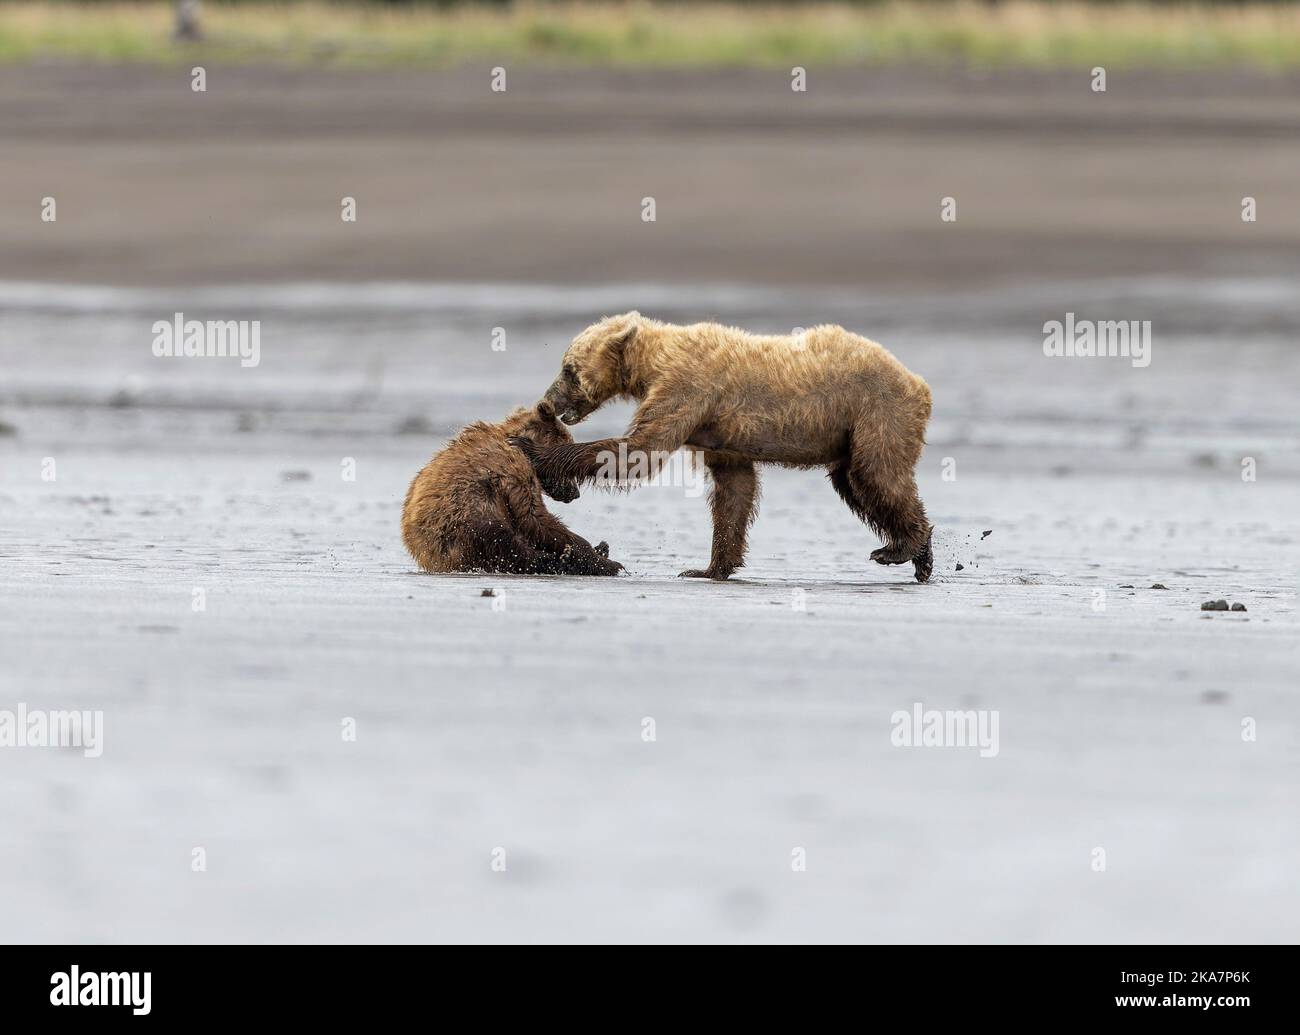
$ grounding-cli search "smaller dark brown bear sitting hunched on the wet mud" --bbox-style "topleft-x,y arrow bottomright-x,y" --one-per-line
402,403 -> 623,575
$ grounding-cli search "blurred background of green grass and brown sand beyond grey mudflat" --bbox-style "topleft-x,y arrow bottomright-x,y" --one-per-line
0,0 -> 1300,290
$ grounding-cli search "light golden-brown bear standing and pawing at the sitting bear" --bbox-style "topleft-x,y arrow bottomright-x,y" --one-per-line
506,312 -> 933,583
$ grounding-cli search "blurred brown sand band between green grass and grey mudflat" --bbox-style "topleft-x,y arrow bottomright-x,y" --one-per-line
0,65 -> 1300,293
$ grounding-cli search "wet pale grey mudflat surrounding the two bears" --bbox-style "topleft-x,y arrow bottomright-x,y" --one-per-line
0,281 -> 1300,943
